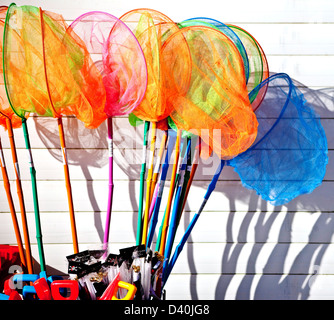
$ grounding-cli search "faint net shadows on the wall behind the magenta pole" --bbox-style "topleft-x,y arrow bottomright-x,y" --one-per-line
32,117 -> 153,240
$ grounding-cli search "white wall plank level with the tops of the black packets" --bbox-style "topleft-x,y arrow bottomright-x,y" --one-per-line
4,242 -> 334,278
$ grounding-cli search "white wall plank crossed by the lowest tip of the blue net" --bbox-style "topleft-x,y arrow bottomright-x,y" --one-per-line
0,181 -> 334,212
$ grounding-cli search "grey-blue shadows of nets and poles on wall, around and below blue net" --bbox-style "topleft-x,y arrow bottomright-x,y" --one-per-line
213,79 -> 334,300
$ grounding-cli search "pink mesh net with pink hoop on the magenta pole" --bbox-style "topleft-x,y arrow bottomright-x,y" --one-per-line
70,11 -> 147,117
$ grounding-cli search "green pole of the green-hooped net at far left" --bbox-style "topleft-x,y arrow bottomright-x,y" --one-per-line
22,119 -> 45,271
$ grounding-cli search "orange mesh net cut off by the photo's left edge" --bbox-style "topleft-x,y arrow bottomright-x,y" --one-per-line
0,6 -> 22,130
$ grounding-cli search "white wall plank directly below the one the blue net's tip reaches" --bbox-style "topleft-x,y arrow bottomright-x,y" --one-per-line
0,210 -> 334,247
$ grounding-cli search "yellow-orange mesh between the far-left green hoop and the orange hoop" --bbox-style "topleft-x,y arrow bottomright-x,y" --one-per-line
3,5 -> 52,118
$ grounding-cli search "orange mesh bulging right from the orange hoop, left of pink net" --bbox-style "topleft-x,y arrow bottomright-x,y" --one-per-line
43,11 -> 106,128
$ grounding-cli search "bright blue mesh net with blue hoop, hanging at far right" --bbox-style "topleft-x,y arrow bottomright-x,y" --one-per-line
226,73 -> 328,205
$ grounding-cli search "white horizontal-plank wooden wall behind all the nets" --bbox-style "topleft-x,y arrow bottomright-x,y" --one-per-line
0,0 -> 334,300
